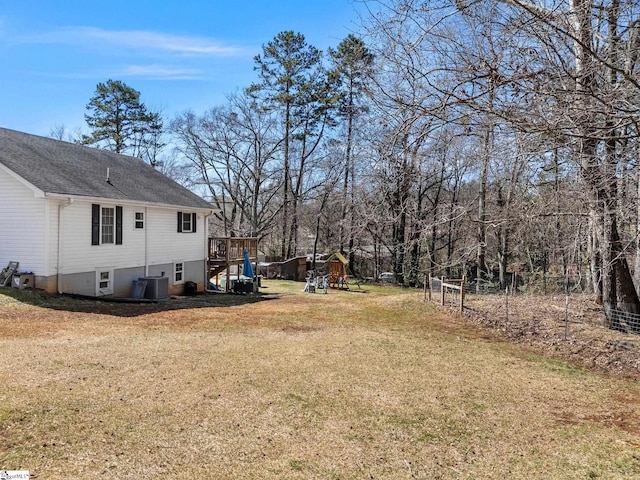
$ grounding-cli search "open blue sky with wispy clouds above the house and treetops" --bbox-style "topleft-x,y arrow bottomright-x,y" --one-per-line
0,0 -> 362,136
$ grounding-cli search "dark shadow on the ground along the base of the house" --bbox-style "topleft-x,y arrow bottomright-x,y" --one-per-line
0,288 -> 279,317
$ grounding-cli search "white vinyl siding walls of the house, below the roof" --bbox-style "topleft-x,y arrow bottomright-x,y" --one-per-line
0,165 -> 206,295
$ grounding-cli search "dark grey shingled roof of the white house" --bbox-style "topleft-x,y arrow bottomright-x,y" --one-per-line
0,128 -> 211,208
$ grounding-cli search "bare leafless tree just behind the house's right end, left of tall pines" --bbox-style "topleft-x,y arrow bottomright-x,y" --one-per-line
171,95 -> 282,237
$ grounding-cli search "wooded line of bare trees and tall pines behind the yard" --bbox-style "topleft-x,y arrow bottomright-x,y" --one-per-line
76,0 -> 640,328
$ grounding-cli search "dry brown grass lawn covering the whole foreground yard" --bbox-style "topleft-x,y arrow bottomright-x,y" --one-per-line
0,281 -> 640,479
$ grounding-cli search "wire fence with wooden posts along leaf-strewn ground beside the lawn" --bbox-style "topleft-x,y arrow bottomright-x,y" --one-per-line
424,277 -> 640,378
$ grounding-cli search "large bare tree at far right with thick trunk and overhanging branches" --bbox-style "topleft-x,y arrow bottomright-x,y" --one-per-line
362,0 -> 640,328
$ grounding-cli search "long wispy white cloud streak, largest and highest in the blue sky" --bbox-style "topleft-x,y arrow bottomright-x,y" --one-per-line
20,27 -> 248,57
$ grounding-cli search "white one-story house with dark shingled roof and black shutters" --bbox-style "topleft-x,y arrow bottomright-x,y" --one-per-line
0,128 -> 213,297
